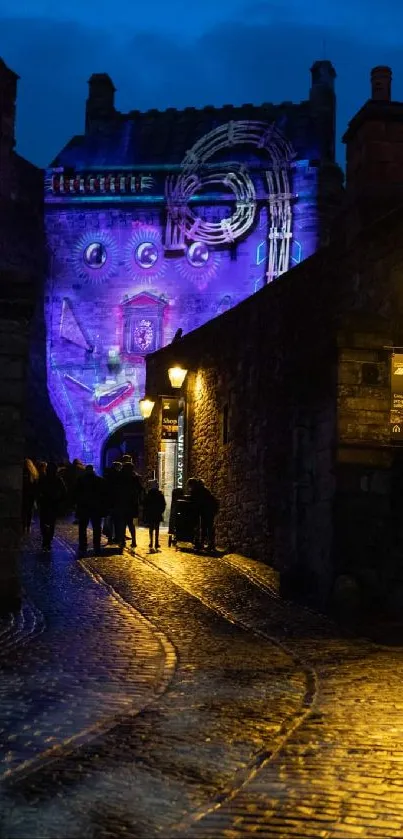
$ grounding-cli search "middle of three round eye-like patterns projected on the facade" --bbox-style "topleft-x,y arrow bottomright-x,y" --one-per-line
124,222 -> 166,282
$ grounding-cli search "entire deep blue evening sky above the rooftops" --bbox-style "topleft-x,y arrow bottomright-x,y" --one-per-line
0,0 -> 403,166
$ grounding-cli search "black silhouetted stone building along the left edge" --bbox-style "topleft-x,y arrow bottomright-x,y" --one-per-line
0,59 -> 61,611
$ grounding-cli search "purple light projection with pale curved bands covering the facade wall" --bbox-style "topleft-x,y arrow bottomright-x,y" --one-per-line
45,121 -> 317,468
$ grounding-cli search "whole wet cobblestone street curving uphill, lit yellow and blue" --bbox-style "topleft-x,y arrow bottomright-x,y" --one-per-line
0,523 -> 403,839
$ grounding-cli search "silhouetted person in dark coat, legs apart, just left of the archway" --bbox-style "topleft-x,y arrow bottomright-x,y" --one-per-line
75,466 -> 106,553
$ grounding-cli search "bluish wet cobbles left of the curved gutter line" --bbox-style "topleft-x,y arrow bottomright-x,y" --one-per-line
0,528 -> 172,777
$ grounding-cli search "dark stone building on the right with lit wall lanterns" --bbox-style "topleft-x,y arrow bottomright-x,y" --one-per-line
146,68 -> 403,614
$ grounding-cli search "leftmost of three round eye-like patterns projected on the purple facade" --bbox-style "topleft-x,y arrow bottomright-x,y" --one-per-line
73,230 -> 118,285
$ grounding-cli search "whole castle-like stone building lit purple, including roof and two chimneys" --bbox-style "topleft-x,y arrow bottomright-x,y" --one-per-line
45,61 -> 342,467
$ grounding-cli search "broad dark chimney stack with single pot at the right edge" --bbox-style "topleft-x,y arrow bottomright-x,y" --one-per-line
343,67 -> 403,232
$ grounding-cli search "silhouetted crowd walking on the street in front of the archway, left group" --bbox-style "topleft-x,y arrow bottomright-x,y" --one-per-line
22,454 -> 166,553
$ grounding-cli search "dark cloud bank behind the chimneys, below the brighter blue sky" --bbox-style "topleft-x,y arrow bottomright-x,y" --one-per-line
0,12 -> 403,165
